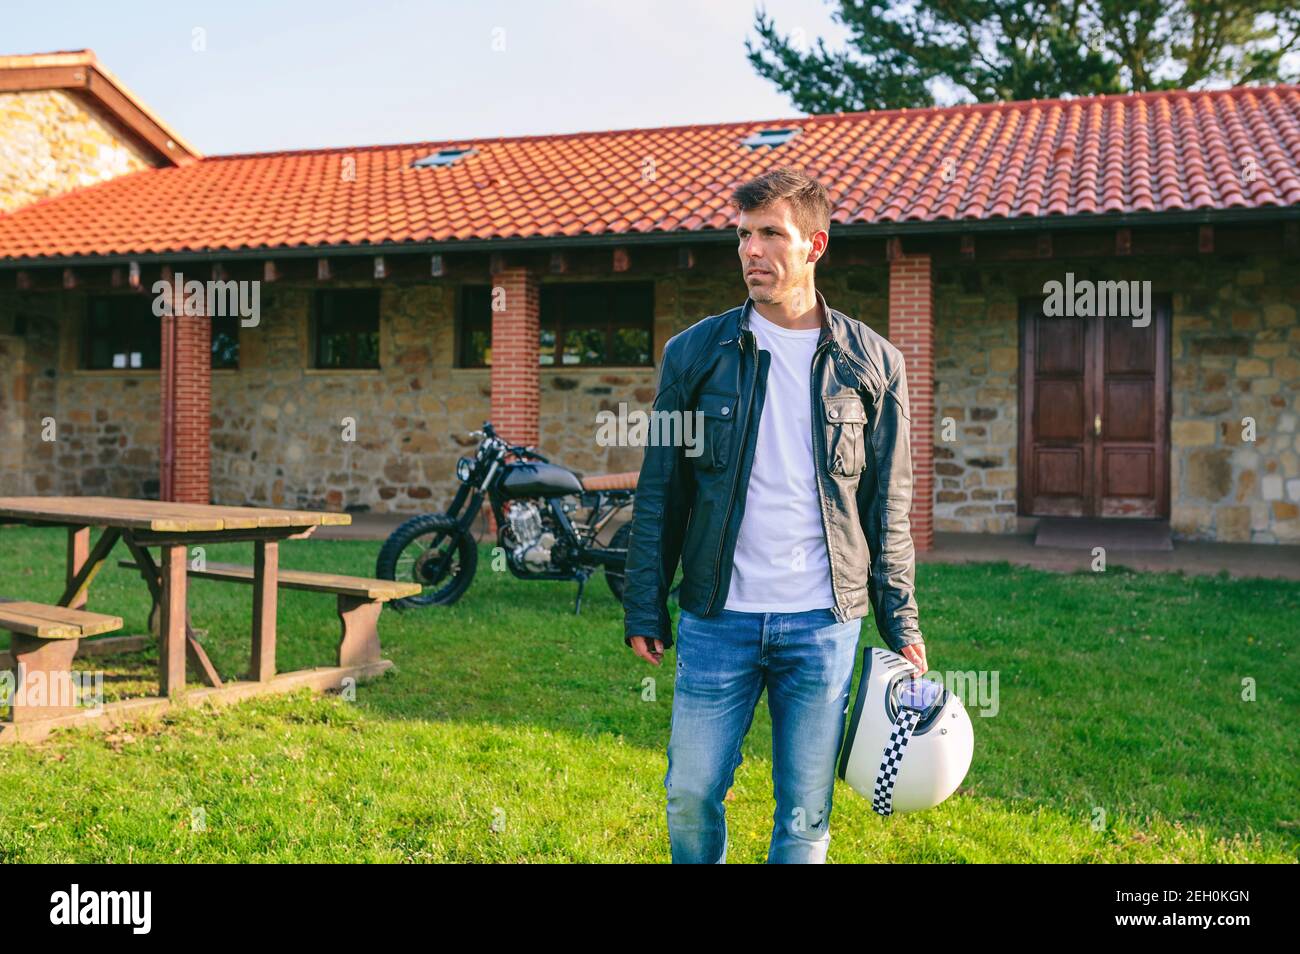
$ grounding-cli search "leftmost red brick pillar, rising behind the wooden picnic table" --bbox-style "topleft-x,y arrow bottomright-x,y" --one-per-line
159,269 -> 212,503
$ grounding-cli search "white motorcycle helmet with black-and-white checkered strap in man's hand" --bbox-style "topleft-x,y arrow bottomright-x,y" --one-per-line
840,647 -> 975,815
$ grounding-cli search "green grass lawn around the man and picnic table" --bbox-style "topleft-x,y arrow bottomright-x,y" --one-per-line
0,528 -> 1300,862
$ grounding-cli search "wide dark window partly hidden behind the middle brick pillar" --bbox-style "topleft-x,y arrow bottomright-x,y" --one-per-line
459,282 -> 654,368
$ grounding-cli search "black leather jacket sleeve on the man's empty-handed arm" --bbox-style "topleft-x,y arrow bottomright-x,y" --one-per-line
623,338 -> 694,649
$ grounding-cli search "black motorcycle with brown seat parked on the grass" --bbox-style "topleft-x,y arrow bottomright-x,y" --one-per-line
376,422 -> 676,613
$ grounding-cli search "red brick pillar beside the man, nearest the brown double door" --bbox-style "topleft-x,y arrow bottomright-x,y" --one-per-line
889,255 -> 935,552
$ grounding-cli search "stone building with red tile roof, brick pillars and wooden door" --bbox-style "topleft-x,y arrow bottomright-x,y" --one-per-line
0,52 -> 1300,548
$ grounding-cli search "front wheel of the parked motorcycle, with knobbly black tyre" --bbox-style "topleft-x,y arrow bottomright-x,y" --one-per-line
374,513 -> 478,610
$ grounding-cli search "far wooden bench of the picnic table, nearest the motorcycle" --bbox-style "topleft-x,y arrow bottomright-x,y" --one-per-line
118,560 -> 424,665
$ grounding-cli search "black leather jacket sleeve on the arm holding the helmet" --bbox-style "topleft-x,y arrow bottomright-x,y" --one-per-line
858,355 -> 922,652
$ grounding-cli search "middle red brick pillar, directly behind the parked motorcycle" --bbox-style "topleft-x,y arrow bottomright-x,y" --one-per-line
491,268 -> 545,454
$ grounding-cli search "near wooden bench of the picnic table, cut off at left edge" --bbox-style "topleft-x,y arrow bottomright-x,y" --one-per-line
0,598 -> 122,723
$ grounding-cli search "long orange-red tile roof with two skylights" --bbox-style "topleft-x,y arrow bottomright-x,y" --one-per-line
0,86 -> 1300,260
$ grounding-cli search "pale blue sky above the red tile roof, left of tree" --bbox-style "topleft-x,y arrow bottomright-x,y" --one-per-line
0,0 -> 846,155
